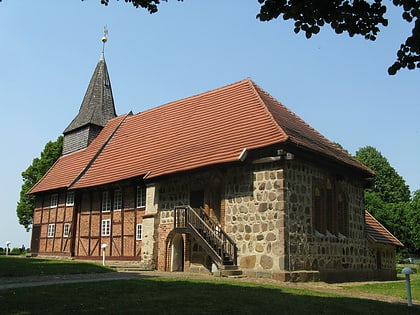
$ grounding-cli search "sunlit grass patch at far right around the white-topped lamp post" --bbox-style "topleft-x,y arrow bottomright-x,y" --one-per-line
343,273 -> 420,301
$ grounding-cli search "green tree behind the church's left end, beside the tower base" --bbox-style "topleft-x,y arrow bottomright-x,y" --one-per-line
16,136 -> 63,230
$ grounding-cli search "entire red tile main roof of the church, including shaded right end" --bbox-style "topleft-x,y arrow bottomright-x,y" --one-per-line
31,79 -> 373,193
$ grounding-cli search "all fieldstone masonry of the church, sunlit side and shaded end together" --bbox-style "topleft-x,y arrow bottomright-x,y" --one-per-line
145,160 -> 395,281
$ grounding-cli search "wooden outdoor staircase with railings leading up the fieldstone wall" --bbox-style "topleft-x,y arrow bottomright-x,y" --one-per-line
174,206 -> 242,276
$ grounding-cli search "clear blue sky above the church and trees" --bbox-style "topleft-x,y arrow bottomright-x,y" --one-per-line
0,0 -> 420,247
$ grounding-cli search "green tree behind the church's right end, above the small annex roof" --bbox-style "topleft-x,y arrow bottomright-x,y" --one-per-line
356,146 -> 410,203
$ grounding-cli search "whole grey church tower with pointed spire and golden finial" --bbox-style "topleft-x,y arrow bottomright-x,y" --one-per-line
62,29 -> 117,155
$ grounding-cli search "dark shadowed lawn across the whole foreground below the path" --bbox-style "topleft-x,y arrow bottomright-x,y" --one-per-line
0,278 -> 419,315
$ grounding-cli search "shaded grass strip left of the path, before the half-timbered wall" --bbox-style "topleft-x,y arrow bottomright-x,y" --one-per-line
0,256 -> 112,276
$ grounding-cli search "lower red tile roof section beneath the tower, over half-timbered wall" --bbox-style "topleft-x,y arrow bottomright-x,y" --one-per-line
28,116 -> 126,194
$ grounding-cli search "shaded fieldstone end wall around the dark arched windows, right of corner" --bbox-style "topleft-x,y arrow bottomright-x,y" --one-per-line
285,162 -> 369,271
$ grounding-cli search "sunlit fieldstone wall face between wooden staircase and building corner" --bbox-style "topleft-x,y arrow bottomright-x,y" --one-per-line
225,164 -> 288,277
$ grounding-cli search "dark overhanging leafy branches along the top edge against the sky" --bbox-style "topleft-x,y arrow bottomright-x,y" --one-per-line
91,0 -> 420,75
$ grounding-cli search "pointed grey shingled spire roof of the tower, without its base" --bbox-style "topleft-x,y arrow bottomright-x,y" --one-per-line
63,55 -> 116,133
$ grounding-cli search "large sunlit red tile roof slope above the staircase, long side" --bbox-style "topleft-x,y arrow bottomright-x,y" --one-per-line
74,80 -> 287,188
